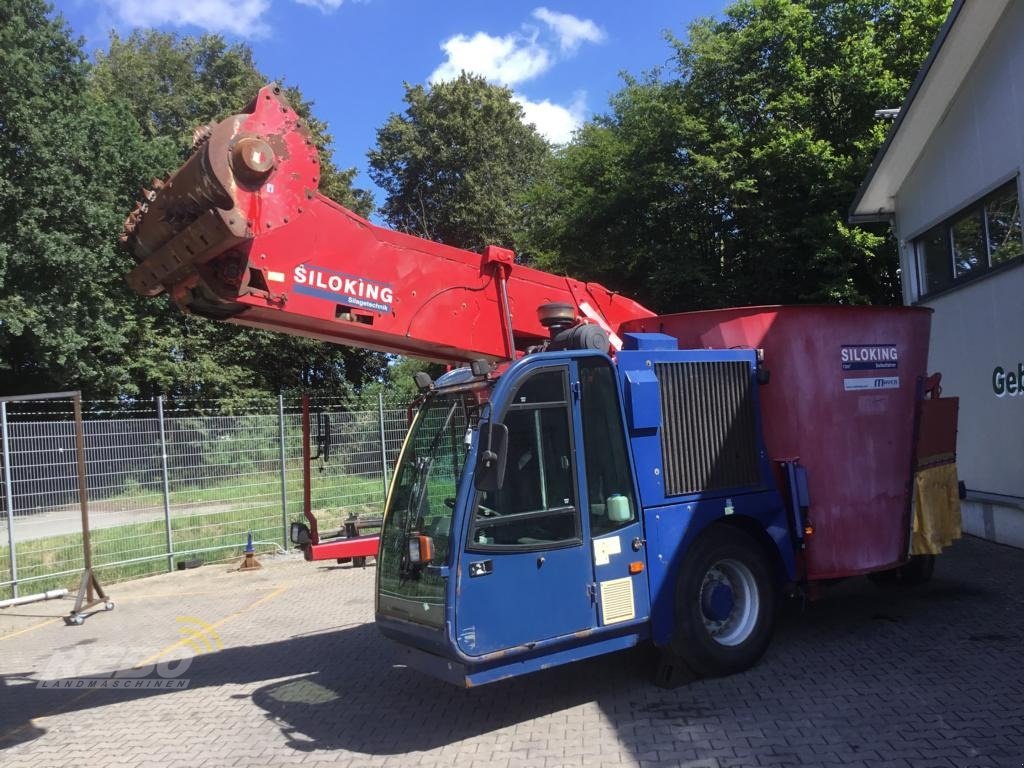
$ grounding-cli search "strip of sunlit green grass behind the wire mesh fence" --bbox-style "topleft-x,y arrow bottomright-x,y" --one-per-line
0,467 -> 384,599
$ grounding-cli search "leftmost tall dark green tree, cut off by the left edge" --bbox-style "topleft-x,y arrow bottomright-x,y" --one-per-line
0,0 -> 167,395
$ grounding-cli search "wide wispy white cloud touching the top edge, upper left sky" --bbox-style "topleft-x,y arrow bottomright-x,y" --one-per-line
96,0 -> 270,37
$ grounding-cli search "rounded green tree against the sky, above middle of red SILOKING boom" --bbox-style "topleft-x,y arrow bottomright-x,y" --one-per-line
369,73 -> 550,249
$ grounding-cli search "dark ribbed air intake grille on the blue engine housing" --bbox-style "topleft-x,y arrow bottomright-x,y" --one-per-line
654,361 -> 760,496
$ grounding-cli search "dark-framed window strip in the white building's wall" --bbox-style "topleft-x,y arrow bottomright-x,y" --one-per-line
914,179 -> 1024,297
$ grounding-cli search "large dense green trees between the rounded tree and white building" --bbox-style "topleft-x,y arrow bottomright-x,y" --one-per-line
529,0 -> 949,311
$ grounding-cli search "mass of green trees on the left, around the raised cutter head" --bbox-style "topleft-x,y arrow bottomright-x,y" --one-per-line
0,10 -> 387,399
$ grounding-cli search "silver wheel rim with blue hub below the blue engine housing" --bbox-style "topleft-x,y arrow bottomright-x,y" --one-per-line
698,558 -> 760,645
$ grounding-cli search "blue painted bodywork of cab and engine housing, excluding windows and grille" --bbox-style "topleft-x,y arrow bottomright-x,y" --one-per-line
378,342 -> 796,685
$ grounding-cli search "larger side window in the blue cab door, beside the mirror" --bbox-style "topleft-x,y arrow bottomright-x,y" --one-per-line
469,368 -> 580,550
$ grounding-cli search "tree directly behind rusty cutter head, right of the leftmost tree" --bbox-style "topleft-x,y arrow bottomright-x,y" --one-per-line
90,30 -> 387,398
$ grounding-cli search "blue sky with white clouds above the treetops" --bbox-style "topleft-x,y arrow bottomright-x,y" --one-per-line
55,0 -> 727,197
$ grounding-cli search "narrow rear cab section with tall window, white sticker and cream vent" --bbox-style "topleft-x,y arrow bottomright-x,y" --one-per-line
577,355 -> 650,627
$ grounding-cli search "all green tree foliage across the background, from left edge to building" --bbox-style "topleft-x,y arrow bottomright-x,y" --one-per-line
0,0 -> 950,399
